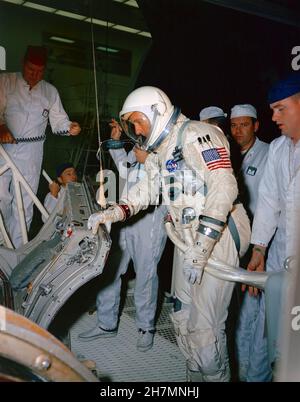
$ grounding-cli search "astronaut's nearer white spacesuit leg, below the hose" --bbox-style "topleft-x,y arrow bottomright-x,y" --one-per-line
188,264 -> 234,381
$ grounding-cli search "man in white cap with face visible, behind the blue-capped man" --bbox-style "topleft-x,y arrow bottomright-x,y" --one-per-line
230,104 -> 269,381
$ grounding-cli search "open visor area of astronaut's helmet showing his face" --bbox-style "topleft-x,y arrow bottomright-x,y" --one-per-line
121,112 -> 151,145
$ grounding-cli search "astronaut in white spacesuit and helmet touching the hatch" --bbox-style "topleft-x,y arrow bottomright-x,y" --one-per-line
88,87 -> 250,381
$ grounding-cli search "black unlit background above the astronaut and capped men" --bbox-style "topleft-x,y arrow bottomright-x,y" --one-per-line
136,0 -> 300,142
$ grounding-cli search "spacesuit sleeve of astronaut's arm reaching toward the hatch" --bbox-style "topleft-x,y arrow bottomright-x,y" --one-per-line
120,154 -> 160,215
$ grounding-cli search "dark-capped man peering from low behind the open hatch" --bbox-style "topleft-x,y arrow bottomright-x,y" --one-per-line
42,162 -> 77,222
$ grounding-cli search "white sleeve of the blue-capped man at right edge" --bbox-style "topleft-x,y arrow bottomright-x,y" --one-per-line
251,143 -> 280,247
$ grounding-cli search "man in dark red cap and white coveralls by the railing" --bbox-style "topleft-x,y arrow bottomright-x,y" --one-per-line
0,46 -> 81,247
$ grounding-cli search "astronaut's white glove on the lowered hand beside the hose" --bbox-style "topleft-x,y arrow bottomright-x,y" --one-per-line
183,229 -> 218,285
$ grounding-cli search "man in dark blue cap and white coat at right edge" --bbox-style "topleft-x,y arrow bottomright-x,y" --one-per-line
239,73 -> 300,381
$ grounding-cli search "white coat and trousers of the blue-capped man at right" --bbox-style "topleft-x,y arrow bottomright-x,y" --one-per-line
237,136 -> 300,382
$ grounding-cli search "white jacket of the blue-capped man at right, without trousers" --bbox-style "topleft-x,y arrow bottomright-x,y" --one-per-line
251,136 -> 300,271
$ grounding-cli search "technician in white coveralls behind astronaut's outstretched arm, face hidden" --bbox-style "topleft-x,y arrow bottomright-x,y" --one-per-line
79,120 -> 167,352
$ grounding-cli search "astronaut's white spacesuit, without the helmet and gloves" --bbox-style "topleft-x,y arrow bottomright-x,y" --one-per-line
122,115 -> 250,381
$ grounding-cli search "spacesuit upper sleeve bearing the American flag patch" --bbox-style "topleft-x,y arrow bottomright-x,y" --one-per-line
183,125 -> 238,222
